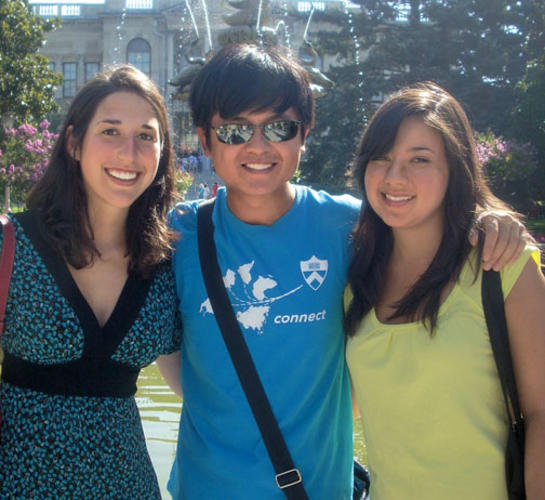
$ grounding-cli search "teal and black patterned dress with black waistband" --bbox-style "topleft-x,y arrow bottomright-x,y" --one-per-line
0,212 -> 181,500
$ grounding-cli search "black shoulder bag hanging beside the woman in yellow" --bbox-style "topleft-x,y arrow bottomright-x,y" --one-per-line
481,271 -> 526,500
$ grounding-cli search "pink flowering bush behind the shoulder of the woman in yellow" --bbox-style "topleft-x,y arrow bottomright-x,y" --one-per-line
476,131 -> 538,213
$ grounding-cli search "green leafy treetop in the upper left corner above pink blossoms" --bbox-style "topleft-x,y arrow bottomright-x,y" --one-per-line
0,0 -> 62,124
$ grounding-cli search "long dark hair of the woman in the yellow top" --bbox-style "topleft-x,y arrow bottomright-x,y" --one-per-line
345,82 -> 508,335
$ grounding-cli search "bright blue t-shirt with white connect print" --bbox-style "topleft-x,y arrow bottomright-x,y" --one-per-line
168,186 -> 361,500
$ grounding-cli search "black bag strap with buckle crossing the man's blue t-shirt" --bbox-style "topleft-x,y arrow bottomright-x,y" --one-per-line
197,199 -> 308,500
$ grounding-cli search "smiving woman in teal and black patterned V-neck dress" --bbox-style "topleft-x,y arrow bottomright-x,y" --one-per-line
0,66 -> 181,499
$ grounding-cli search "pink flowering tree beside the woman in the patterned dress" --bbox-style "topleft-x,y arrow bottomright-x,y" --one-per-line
0,120 -> 58,212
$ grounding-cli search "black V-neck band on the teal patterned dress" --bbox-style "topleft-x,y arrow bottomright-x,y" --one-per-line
15,211 -> 151,357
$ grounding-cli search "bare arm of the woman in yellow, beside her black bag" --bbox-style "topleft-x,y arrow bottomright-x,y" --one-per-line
505,258 -> 545,500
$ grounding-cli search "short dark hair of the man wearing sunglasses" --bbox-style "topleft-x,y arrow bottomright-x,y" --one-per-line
189,44 -> 314,145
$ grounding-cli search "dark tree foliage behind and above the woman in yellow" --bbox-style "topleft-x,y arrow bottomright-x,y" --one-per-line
302,0 -> 545,199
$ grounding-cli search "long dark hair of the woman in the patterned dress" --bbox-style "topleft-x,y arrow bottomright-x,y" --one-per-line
27,65 -> 175,277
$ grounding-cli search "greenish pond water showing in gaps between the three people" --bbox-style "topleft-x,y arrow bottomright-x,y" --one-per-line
136,364 -> 366,500
